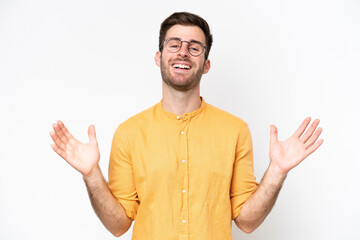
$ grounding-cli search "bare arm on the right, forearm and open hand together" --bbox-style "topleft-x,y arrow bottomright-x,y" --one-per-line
235,118 -> 323,233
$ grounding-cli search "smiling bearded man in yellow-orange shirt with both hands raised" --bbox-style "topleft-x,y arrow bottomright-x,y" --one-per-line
50,12 -> 323,240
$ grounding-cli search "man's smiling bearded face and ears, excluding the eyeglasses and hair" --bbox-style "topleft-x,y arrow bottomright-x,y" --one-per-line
155,25 -> 210,91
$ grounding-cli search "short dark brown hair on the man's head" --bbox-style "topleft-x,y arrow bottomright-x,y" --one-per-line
159,12 -> 213,59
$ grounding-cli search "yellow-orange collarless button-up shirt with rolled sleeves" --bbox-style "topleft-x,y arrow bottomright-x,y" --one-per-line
108,100 -> 257,240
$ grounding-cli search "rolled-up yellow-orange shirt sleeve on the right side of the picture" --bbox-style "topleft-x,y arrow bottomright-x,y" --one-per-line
230,123 -> 258,219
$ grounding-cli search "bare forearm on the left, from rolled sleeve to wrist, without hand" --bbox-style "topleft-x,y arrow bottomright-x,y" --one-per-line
83,166 -> 132,236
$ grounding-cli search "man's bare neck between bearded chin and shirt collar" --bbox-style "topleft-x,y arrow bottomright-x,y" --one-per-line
162,82 -> 201,115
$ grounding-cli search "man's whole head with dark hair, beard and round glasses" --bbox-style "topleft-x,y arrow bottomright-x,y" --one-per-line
155,13 -> 212,92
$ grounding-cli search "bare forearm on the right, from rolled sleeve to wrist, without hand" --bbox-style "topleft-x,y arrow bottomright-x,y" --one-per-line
235,164 -> 286,233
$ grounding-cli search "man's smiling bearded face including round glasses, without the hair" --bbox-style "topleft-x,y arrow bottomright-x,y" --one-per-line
155,25 -> 212,92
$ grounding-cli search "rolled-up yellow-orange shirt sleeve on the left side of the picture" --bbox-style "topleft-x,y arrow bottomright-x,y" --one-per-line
108,125 -> 140,220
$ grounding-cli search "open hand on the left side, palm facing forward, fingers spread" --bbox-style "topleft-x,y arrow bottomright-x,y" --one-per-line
50,121 -> 100,176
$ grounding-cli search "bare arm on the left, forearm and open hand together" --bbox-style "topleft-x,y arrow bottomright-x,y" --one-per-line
50,121 -> 132,236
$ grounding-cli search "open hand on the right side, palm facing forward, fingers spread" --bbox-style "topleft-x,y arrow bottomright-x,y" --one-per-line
269,117 -> 323,174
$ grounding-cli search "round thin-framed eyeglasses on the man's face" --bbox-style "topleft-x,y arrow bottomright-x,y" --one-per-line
164,38 -> 206,57
